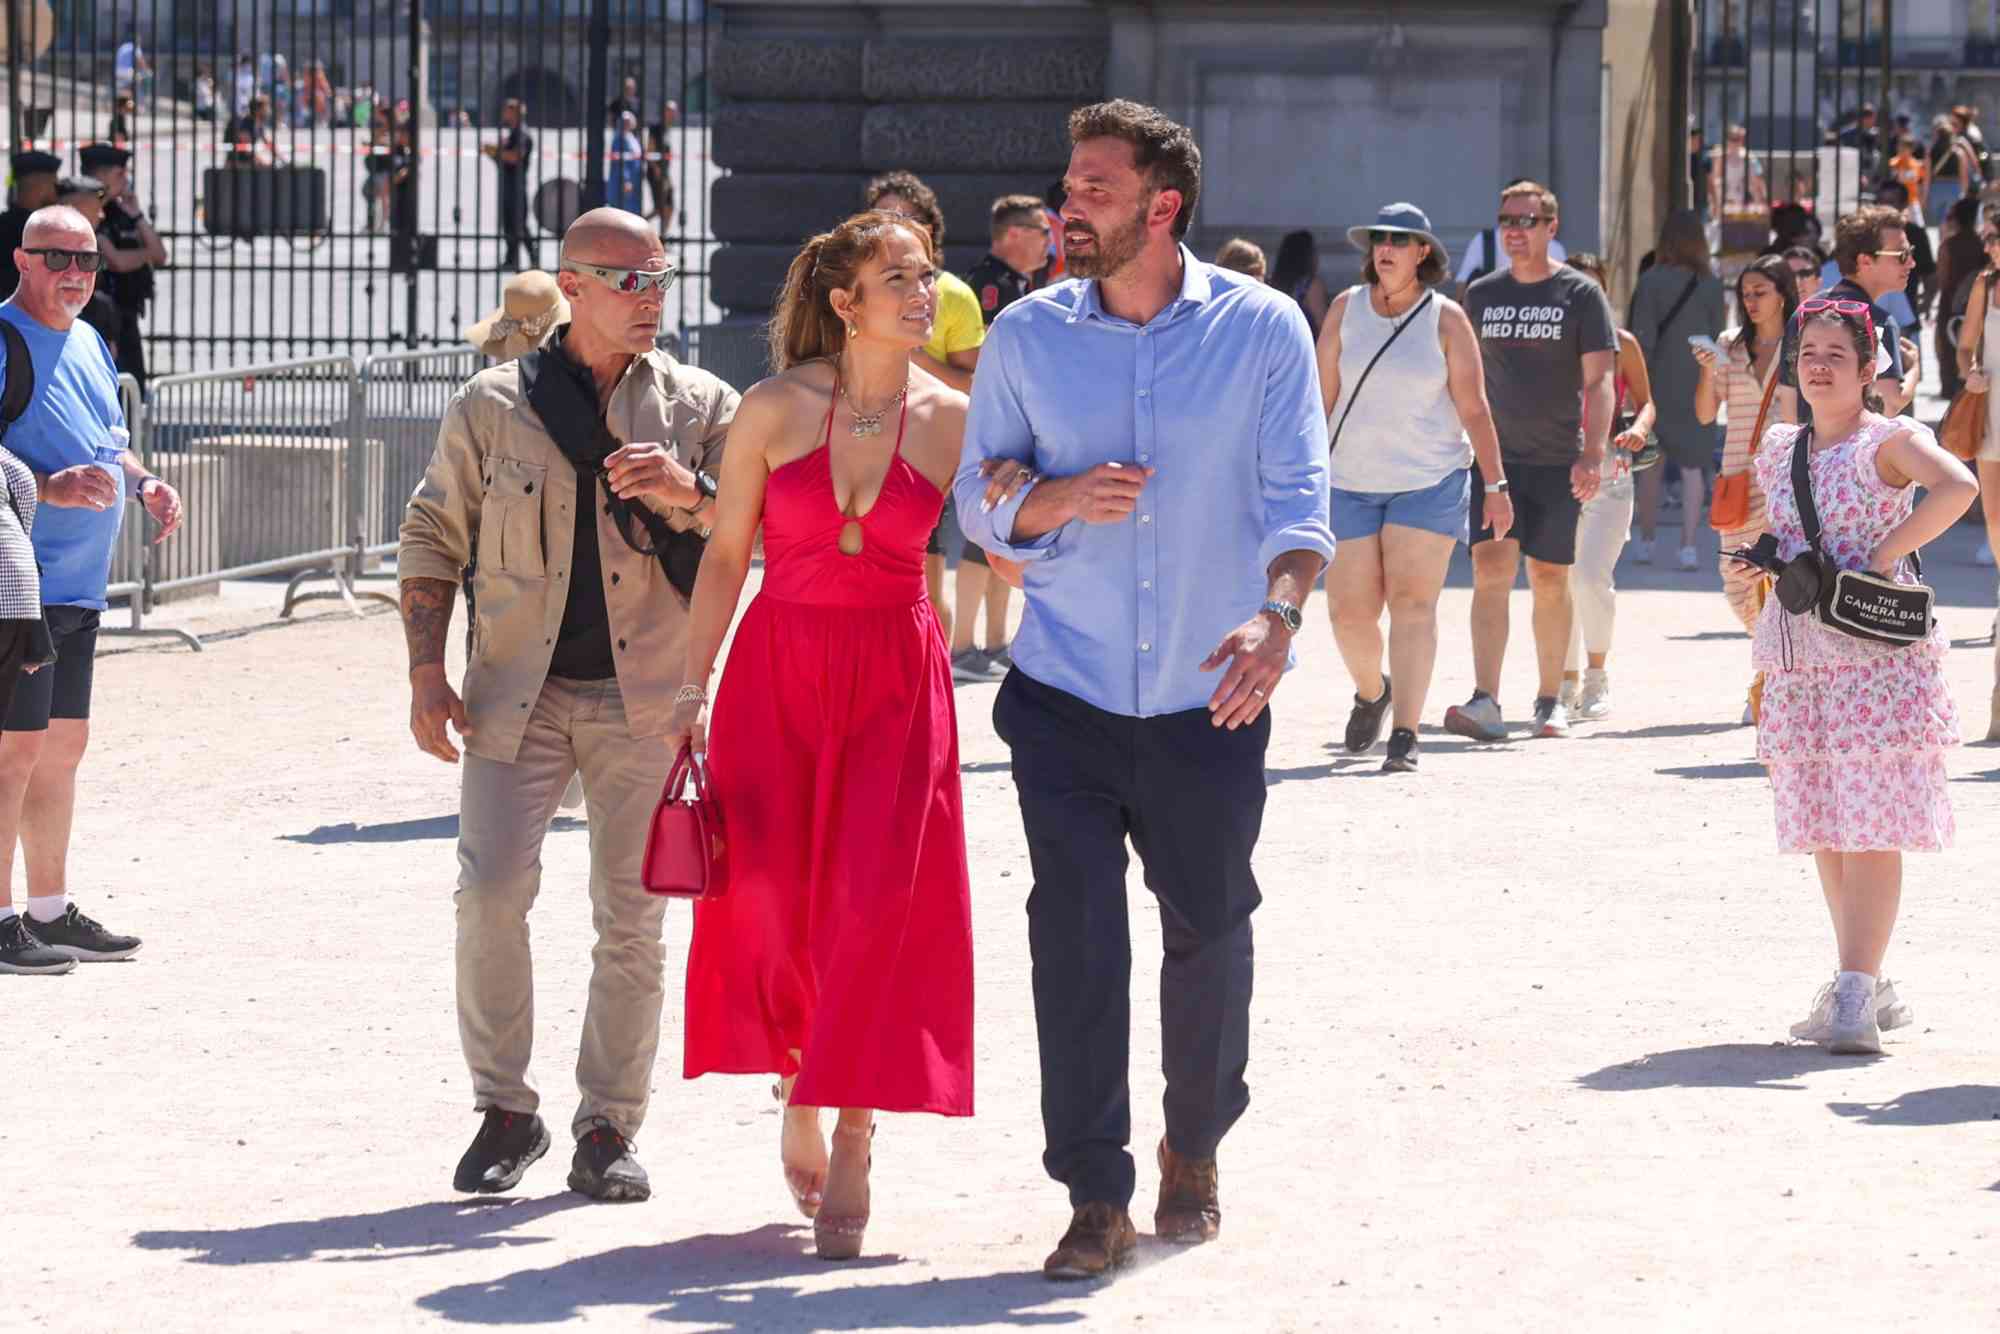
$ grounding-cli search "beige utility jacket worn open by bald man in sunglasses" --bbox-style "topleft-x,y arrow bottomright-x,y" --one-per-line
396,352 -> 738,764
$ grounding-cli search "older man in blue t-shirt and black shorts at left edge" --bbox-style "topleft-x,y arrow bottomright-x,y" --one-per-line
0,204 -> 180,970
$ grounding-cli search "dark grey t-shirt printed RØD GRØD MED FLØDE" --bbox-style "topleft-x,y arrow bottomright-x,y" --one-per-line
1466,266 -> 1618,466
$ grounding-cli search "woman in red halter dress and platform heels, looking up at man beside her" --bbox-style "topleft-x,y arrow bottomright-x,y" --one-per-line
674,212 -> 972,1260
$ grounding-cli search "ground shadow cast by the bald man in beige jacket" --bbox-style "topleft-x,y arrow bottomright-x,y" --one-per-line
132,1190 -> 590,1264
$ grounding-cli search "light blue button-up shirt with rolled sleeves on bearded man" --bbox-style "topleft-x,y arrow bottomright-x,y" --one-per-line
952,246 -> 1334,718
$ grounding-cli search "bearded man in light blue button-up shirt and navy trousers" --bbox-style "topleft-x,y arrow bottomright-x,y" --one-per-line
954,100 -> 1334,1278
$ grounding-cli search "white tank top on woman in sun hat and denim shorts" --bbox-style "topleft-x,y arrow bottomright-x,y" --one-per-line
1326,286 -> 1472,492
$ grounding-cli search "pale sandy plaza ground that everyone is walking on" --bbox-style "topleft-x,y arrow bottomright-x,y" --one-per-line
15,506 -> 2000,1334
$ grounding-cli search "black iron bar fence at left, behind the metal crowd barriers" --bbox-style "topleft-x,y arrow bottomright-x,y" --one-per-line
4,0 -> 718,374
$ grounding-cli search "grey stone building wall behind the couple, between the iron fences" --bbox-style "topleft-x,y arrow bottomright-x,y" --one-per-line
704,0 -> 1678,386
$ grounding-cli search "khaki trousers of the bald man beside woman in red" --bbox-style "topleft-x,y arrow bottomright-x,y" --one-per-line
454,676 -> 672,1138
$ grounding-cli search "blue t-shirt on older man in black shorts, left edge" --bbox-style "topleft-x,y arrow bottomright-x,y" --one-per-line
0,300 -> 130,610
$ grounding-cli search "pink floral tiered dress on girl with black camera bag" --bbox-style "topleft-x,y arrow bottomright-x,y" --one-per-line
1752,414 -> 1958,852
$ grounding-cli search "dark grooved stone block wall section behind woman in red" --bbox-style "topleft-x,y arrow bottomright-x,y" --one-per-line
708,16 -> 1110,324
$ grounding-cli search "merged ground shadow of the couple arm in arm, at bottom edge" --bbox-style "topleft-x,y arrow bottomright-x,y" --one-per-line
416,1224 -> 1088,1330
